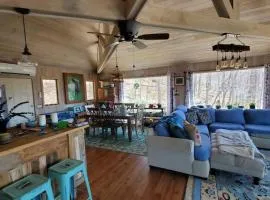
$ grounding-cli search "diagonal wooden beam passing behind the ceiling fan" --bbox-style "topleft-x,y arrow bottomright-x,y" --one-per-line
97,0 -> 147,74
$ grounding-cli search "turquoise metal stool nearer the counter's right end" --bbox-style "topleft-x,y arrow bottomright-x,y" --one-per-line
49,159 -> 92,200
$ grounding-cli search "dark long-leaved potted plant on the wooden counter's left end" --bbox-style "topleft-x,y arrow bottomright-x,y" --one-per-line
0,101 -> 33,144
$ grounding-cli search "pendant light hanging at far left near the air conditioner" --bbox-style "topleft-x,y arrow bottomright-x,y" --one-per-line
15,8 -> 38,67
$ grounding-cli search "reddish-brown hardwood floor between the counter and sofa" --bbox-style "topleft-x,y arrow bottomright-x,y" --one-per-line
77,147 -> 187,200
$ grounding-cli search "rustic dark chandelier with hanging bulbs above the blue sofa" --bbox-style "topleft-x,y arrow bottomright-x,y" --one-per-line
212,33 -> 250,71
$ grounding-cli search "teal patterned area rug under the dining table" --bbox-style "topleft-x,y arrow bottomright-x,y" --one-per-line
86,132 -> 147,156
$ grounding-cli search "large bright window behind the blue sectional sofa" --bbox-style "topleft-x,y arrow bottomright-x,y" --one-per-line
192,68 -> 264,108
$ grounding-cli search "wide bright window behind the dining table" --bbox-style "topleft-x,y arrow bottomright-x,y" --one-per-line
123,76 -> 168,110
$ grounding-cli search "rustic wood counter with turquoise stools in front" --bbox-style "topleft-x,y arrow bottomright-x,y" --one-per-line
0,126 -> 88,188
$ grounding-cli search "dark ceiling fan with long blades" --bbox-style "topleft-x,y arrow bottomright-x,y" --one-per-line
87,20 -> 170,49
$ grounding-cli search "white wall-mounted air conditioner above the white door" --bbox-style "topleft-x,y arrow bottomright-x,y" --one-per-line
0,63 -> 36,76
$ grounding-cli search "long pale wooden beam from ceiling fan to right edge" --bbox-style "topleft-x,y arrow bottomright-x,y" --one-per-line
137,4 -> 270,38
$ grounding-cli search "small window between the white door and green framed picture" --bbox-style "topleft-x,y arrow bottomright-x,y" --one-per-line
42,80 -> 58,105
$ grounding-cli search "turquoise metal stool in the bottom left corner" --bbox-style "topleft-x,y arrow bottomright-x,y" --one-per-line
0,174 -> 54,200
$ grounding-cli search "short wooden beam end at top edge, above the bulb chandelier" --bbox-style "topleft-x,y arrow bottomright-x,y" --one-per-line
212,0 -> 240,19
